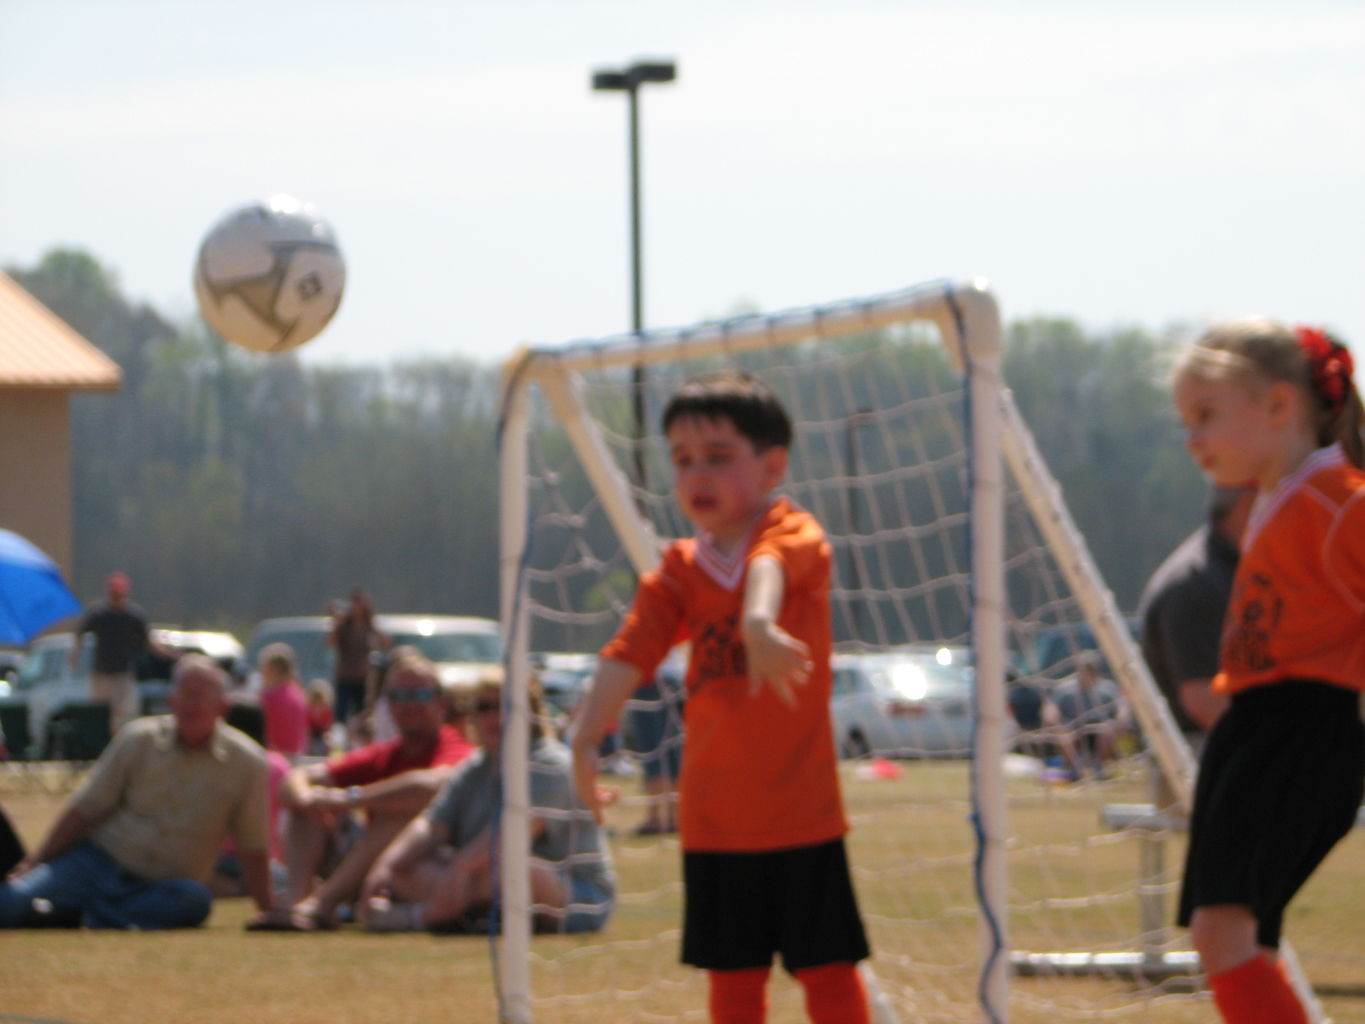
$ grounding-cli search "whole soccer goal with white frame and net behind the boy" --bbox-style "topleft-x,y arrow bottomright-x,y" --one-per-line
497,283 -> 1326,1024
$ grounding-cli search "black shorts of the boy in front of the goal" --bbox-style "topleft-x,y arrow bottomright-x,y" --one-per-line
683,838 -> 868,972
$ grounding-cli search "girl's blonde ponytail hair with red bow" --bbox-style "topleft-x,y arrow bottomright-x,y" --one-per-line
1174,317 -> 1365,467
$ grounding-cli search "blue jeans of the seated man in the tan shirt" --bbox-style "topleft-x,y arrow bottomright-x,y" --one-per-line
0,840 -> 213,930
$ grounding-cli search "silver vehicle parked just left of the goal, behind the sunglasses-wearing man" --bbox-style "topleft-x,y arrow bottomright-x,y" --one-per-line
247,614 -> 502,688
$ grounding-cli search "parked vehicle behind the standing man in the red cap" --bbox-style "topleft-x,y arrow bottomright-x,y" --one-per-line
12,627 -> 243,756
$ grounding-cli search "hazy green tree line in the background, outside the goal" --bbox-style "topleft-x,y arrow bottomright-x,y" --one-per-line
8,250 -> 1205,638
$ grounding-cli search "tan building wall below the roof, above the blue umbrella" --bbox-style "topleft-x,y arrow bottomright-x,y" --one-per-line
0,388 -> 74,579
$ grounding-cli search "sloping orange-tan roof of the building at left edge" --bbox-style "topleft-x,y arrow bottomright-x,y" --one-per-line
0,270 -> 123,390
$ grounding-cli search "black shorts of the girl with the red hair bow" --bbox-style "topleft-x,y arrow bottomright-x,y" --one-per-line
1178,680 -> 1365,948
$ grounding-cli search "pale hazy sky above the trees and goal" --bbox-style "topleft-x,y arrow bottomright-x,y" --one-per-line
0,0 -> 1365,366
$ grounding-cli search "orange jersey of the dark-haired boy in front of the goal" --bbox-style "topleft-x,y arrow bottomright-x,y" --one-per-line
602,498 -> 848,852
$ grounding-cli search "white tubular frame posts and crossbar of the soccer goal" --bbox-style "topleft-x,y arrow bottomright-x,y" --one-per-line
497,280 -> 1321,1024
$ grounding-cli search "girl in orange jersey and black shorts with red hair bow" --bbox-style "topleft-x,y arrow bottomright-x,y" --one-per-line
1173,318 -> 1365,1024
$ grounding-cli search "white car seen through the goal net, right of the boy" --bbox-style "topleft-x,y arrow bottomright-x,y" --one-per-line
830,646 -> 975,758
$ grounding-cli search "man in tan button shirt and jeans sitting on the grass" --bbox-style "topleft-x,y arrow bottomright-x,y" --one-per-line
0,654 -> 272,928
